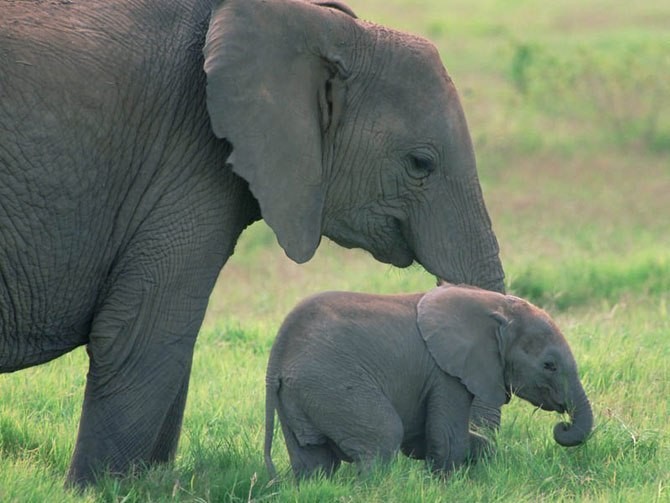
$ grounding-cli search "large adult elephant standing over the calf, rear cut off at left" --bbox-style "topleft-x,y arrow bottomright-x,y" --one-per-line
0,0 -> 503,484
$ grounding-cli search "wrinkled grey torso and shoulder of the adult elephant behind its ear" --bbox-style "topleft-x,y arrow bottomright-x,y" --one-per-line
0,2 -> 257,371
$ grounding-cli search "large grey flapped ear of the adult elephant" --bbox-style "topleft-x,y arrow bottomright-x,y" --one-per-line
204,0 -> 353,262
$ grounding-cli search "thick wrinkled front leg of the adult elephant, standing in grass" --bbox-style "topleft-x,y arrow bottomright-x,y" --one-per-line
68,225 -> 221,484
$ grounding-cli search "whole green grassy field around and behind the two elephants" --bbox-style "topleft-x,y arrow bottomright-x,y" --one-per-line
0,0 -> 670,502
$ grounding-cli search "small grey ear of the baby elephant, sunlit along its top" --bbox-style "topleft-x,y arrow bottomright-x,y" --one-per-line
417,287 -> 506,407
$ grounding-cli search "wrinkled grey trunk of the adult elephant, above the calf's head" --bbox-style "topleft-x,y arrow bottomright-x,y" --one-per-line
405,81 -> 505,293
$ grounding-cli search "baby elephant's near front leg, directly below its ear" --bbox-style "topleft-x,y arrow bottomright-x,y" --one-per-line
426,376 -> 472,472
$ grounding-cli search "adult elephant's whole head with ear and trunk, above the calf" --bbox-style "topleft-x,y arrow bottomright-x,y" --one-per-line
204,0 -> 504,291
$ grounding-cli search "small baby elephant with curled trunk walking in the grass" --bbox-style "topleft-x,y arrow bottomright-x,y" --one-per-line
265,285 -> 593,478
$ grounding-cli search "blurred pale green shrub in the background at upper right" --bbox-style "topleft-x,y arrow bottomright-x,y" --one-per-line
509,40 -> 670,151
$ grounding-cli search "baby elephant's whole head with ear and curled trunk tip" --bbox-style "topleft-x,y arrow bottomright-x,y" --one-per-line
418,286 -> 593,446
